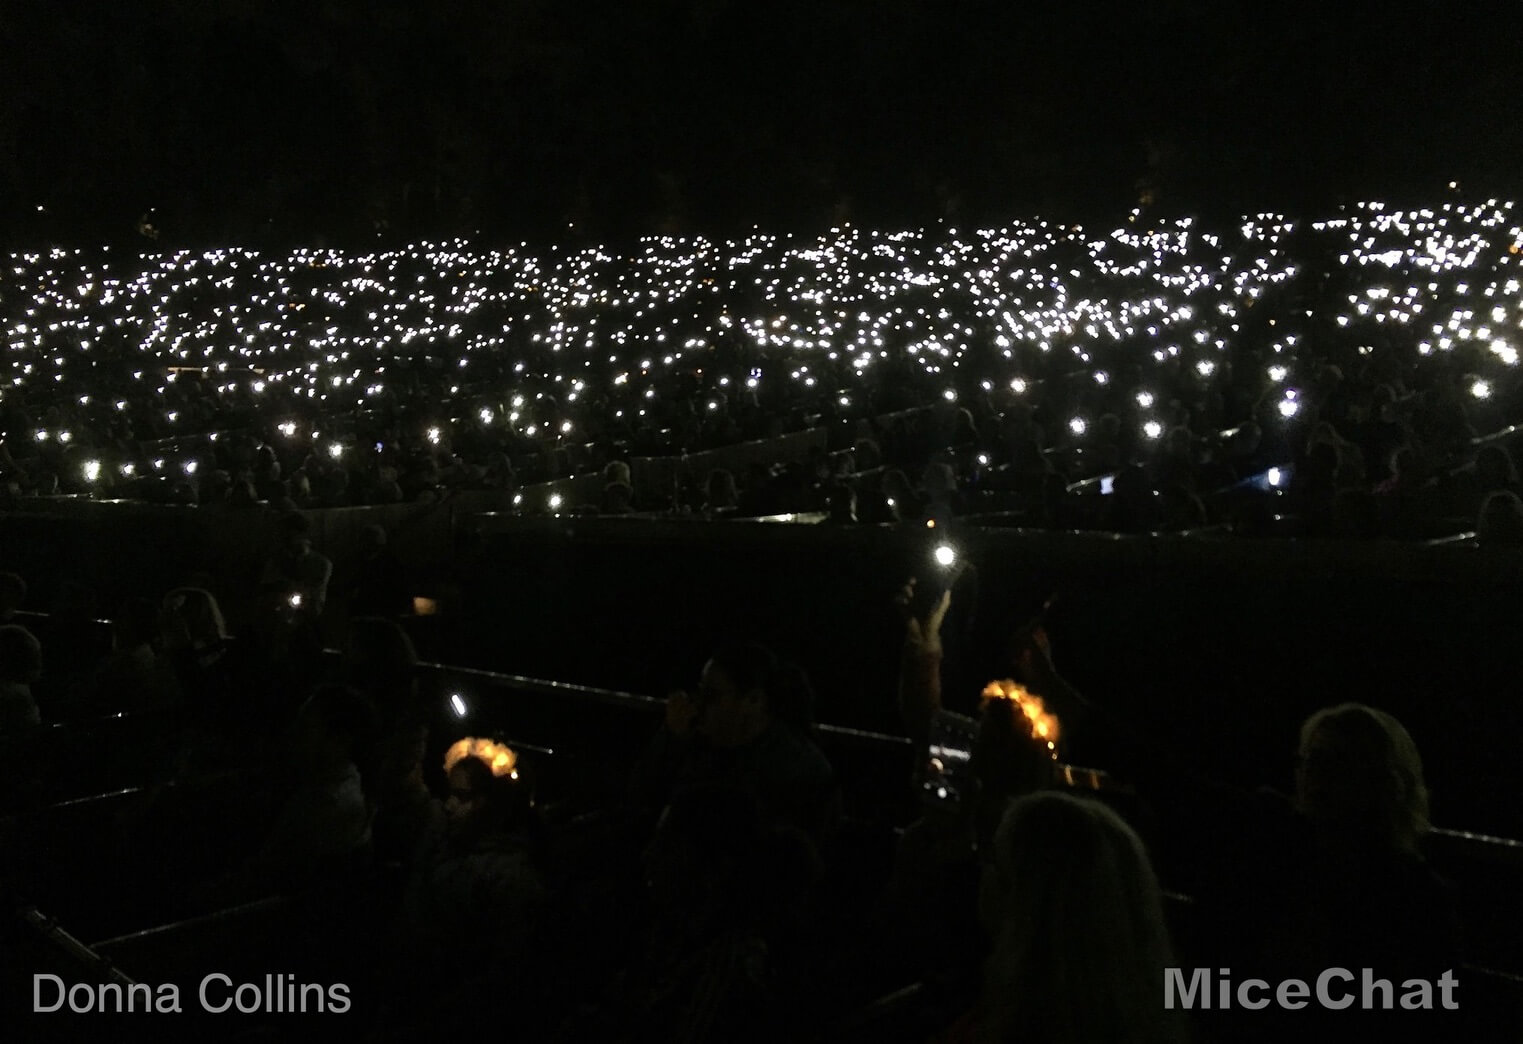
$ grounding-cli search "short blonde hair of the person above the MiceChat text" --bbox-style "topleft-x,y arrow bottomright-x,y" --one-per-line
1301,703 -> 1430,852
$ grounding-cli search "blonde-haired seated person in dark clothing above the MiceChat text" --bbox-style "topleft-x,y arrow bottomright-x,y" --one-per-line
1197,703 -> 1461,1039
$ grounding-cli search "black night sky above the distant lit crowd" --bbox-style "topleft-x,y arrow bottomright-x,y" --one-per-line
0,0 -> 1523,244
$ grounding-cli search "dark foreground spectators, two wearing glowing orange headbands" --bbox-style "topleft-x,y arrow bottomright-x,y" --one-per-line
0,542 -> 1461,1042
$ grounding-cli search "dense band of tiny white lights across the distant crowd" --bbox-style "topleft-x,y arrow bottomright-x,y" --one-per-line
0,200 -> 1523,493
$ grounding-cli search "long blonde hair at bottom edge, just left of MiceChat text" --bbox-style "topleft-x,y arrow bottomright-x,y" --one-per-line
982,791 -> 1185,1044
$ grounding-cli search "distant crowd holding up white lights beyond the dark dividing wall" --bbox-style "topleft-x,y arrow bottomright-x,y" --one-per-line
0,201 -> 1523,538
